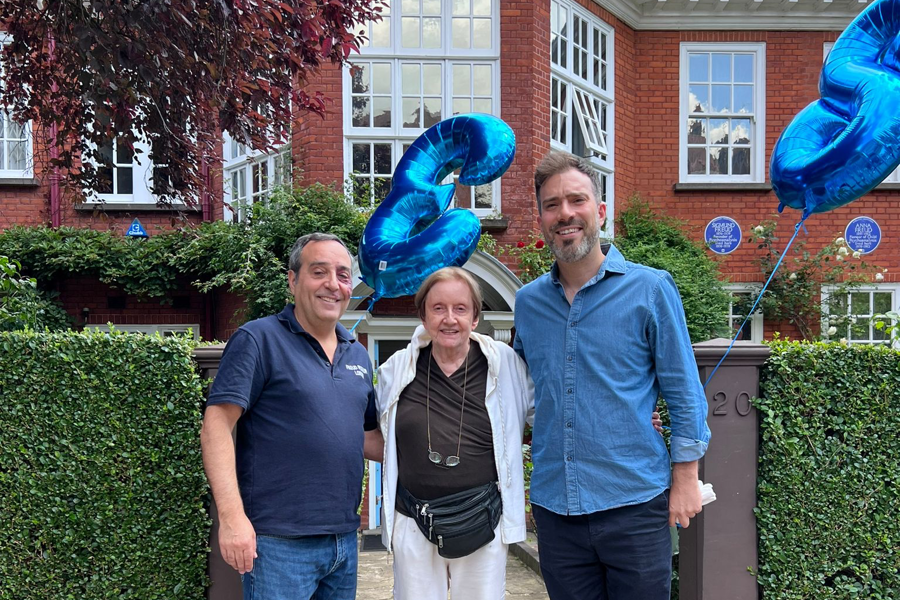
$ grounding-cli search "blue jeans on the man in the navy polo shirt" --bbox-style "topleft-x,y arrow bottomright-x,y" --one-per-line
241,531 -> 357,600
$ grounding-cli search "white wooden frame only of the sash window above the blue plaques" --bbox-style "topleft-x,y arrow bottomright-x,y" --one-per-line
678,42 -> 766,183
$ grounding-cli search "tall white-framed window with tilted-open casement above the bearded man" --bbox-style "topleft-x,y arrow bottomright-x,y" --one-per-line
550,0 -> 615,235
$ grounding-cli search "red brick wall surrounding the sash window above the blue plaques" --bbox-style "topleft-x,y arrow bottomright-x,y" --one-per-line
616,25 -> 900,296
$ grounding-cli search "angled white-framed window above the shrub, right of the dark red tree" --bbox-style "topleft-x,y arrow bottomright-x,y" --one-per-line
222,132 -> 291,221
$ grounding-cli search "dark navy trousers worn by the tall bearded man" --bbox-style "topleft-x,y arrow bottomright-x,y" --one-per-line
532,492 -> 672,600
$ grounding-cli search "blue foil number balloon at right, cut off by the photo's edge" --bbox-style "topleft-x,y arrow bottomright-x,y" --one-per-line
770,0 -> 900,218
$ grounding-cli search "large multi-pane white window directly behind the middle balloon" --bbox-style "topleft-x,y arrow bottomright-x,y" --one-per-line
343,0 -> 500,216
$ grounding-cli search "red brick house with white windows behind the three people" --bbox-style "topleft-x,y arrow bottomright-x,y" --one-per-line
0,0 -> 900,525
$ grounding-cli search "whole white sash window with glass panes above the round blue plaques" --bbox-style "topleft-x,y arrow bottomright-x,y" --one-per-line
678,43 -> 766,183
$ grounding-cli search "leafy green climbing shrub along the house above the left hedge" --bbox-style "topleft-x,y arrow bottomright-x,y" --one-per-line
0,184 -> 366,323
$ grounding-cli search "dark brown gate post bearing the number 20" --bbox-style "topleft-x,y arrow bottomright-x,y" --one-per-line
679,338 -> 769,600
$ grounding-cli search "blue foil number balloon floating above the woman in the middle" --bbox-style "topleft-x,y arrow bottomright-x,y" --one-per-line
359,114 -> 516,301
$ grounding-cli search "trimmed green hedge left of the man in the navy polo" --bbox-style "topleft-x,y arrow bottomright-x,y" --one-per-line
0,332 -> 209,600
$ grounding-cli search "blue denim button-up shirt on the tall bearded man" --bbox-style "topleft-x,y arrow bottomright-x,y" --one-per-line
514,246 -> 710,515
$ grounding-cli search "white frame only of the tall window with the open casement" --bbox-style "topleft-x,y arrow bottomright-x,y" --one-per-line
547,0 -> 616,237
